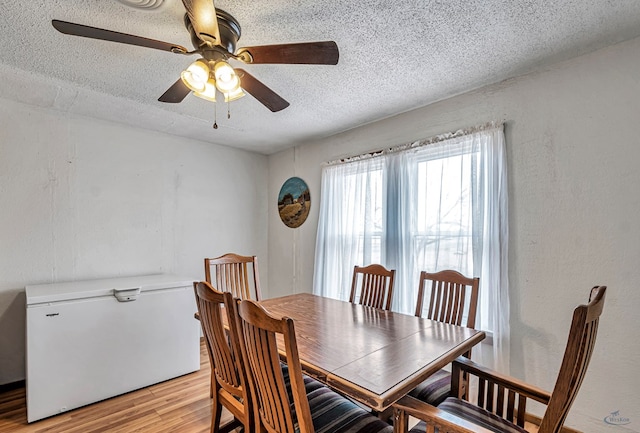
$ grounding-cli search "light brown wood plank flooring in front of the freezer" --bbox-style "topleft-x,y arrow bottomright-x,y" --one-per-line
0,342 -> 231,433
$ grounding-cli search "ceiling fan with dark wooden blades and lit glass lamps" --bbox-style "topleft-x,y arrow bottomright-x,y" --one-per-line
51,0 -> 339,112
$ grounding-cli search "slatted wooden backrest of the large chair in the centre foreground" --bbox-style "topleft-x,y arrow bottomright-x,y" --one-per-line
238,300 -> 314,433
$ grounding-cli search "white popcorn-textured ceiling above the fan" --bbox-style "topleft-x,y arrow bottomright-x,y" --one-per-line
0,0 -> 640,154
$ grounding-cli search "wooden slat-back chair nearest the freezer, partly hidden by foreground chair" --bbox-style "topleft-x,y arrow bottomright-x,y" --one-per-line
193,281 -> 255,433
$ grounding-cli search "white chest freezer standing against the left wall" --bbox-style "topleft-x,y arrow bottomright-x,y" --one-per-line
26,275 -> 200,422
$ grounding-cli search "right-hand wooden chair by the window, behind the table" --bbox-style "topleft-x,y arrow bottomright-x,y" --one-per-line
409,270 -> 480,406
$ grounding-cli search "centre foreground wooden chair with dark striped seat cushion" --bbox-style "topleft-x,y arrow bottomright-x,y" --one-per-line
238,301 -> 393,433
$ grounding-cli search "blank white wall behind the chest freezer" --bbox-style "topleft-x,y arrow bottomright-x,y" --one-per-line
0,99 -> 268,384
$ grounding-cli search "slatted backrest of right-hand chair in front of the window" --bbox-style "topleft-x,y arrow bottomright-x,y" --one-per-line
415,270 -> 480,328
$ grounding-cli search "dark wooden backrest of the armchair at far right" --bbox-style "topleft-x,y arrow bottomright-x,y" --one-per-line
538,286 -> 607,433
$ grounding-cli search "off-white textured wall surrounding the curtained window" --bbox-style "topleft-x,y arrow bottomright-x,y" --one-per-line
269,35 -> 640,433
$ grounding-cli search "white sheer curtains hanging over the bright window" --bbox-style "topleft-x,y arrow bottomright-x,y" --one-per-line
314,126 -> 509,372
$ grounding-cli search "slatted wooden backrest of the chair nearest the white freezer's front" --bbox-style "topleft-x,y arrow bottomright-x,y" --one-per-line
193,281 -> 251,407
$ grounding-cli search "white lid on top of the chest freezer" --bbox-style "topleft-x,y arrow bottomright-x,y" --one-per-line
25,274 -> 198,306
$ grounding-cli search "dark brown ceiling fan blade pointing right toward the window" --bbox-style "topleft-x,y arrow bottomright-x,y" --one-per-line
238,41 -> 339,65
